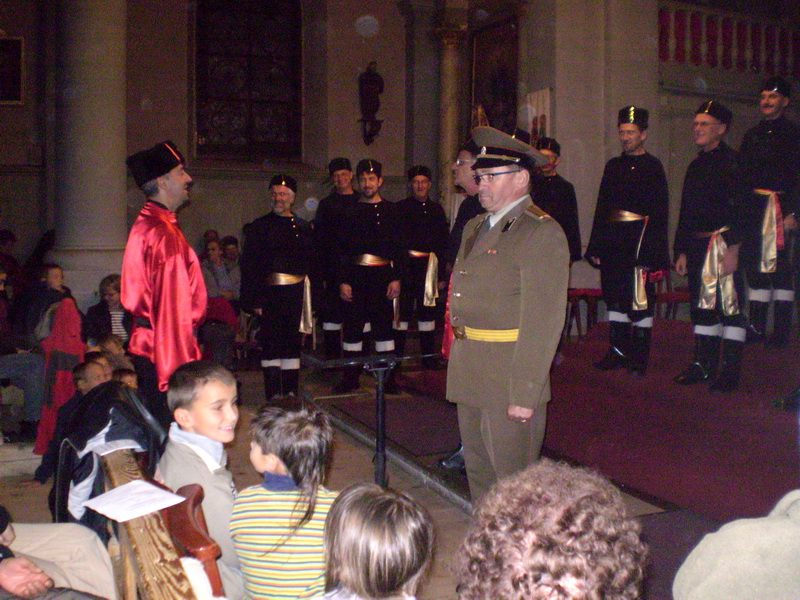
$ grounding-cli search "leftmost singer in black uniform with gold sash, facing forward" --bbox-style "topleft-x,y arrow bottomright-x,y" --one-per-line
241,175 -> 313,400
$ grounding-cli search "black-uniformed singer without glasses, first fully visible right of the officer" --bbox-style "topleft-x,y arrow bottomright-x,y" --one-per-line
586,106 -> 669,375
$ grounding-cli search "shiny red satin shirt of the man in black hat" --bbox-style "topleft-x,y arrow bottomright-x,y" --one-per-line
120,202 -> 208,391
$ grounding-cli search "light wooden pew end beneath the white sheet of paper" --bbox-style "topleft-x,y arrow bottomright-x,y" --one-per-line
102,450 -> 195,600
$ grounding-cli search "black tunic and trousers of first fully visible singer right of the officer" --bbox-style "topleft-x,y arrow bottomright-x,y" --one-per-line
586,153 -> 669,314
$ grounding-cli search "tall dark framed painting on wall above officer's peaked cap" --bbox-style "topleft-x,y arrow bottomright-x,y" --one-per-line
472,18 -> 519,134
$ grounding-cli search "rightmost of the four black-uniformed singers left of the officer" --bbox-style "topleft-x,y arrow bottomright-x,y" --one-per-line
395,165 -> 449,369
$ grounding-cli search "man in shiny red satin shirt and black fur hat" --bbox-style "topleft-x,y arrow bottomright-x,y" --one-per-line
120,141 -> 208,426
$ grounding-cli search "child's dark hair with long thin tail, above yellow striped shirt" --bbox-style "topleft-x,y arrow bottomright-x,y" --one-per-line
251,406 -> 333,529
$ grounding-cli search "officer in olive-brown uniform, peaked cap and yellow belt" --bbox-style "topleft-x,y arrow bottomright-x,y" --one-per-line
447,127 -> 569,502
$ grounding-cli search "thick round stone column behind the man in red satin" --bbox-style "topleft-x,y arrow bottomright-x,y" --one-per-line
52,0 -> 127,308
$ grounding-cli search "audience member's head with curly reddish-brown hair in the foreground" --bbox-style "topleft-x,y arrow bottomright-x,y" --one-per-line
456,459 -> 646,600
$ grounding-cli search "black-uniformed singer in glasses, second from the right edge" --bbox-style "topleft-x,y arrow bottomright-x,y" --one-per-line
674,100 -> 747,391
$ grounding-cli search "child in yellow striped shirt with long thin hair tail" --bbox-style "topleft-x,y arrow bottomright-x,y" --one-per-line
230,407 -> 336,600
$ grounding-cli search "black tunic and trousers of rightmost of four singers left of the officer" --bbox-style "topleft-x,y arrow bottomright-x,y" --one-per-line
397,197 -> 448,328
